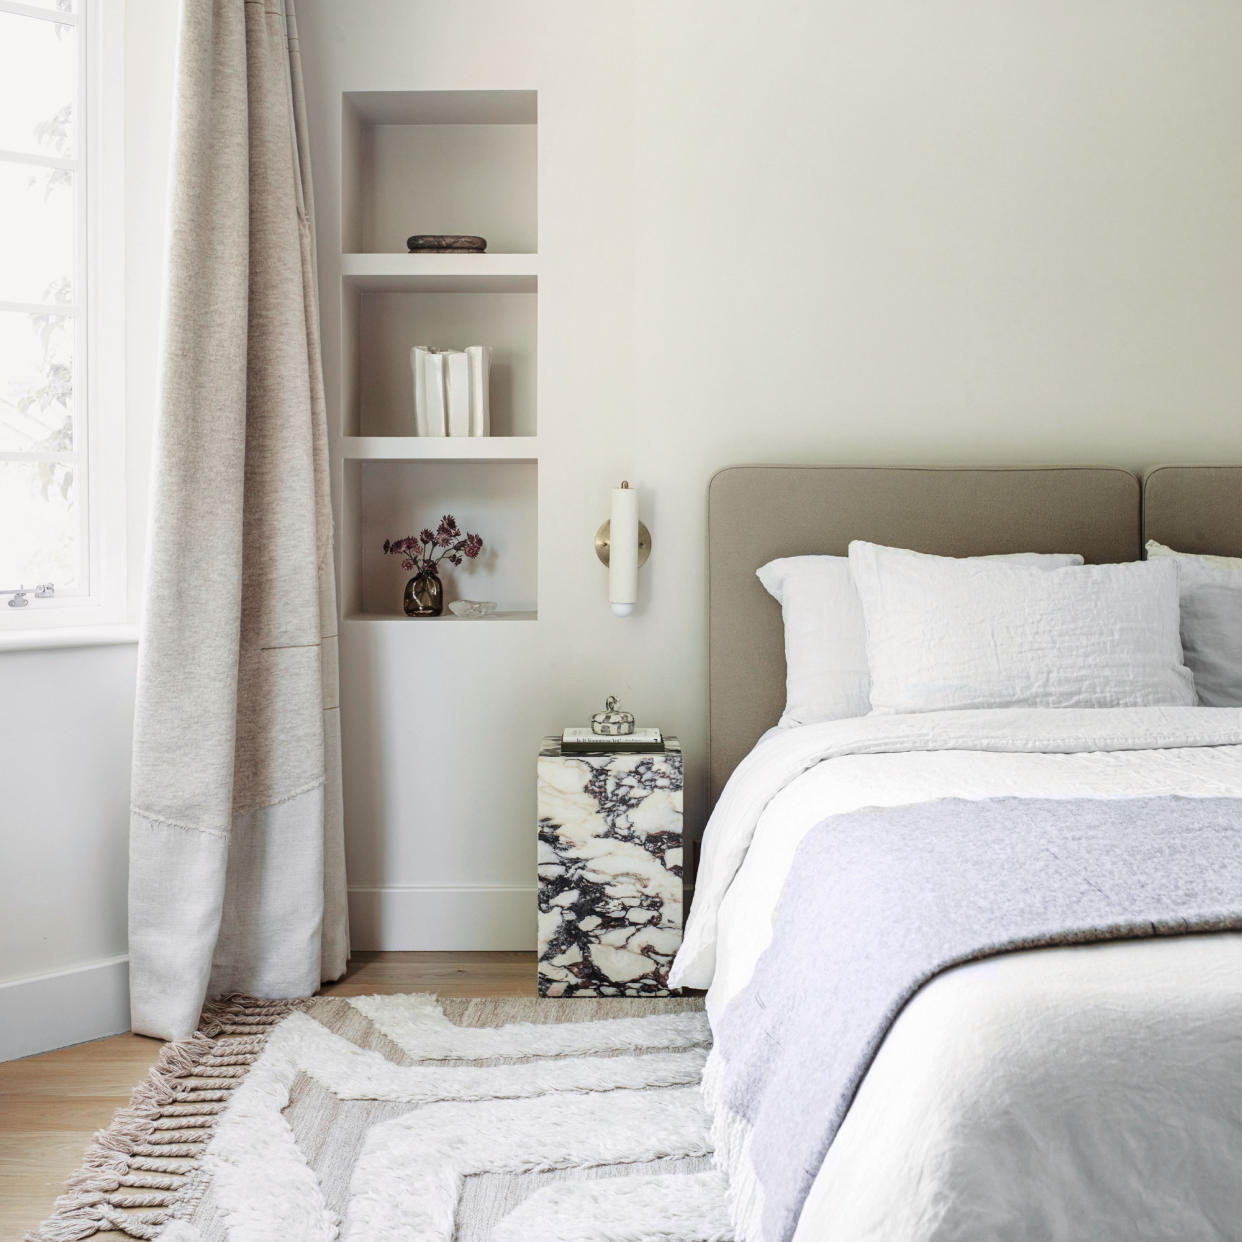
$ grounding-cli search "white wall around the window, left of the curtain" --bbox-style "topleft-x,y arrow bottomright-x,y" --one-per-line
0,0 -> 176,1059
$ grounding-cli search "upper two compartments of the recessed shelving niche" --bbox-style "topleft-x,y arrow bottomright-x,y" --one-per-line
340,91 -> 539,437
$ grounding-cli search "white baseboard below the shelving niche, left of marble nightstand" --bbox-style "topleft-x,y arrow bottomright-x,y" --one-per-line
349,884 -> 538,950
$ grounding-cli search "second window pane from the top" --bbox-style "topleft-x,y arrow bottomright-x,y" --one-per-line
0,161 -> 76,302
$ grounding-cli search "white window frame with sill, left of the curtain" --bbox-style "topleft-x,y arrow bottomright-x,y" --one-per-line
0,0 -> 129,651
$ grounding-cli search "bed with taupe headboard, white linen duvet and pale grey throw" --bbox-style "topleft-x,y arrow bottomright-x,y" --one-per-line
673,467 -> 1242,1242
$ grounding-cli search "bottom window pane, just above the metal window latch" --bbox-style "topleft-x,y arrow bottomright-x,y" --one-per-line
0,462 -> 82,595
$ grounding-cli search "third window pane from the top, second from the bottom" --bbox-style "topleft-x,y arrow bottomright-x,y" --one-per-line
0,311 -> 75,453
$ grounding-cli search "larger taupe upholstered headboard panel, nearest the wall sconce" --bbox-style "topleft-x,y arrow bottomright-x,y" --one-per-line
708,466 -> 1142,804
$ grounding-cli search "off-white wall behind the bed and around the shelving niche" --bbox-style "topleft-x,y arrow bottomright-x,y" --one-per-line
299,0 -> 1242,948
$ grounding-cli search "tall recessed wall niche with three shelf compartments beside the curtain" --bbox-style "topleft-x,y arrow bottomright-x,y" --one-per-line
338,91 -> 539,626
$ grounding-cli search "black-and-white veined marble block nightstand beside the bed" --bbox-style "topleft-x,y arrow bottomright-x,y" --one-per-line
539,738 -> 682,996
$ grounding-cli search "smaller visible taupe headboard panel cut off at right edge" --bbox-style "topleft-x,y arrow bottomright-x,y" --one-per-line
1143,466 -> 1242,556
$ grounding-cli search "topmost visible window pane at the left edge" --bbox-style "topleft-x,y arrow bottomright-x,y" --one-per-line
0,12 -> 77,158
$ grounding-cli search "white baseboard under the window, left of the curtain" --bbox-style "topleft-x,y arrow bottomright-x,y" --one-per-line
0,958 -> 129,1061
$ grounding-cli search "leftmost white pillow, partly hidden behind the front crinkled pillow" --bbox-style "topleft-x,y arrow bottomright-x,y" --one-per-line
756,549 -> 1083,728
